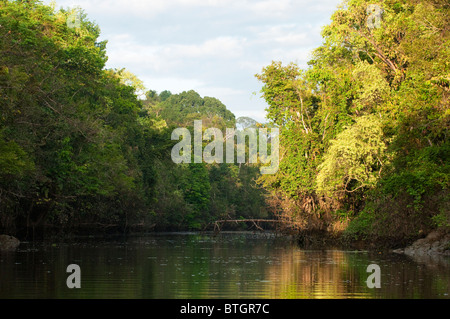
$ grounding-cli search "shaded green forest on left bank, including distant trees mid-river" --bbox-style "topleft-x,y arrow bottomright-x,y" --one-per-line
0,1 -> 267,236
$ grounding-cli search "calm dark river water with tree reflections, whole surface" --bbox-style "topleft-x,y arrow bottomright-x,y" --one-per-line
0,232 -> 450,299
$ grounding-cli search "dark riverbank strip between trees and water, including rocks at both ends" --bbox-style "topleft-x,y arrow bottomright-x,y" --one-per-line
0,225 -> 450,256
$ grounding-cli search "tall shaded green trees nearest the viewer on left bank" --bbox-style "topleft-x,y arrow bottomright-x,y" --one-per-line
0,1 -> 141,230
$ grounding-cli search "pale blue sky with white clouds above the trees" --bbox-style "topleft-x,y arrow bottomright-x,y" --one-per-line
44,0 -> 342,121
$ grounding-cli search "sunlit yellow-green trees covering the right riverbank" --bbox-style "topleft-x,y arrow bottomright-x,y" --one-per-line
257,0 -> 450,246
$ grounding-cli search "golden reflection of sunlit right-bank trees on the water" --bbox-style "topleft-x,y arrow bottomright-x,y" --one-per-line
268,250 -> 450,298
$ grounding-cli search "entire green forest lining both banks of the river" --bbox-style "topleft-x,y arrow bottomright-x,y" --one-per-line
0,0 -> 450,248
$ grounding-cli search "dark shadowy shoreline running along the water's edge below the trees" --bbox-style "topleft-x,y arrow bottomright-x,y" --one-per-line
0,225 -> 450,255
